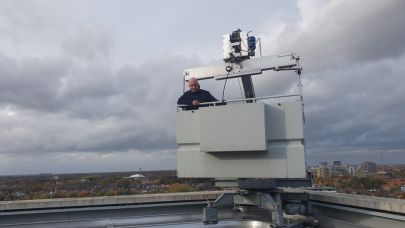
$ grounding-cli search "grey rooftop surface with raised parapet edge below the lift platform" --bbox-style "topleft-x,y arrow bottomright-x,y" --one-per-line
0,190 -> 405,228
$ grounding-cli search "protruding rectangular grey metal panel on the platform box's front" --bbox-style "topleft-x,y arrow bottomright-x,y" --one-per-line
199,103 -> 267,152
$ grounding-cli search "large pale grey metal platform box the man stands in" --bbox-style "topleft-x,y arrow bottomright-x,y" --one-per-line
176,99 -> 306,178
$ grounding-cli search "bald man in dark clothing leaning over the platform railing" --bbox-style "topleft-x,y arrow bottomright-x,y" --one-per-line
177,78 -> 217,110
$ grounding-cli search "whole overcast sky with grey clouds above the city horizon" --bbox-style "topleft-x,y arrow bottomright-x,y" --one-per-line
0,0 -> 405,175
